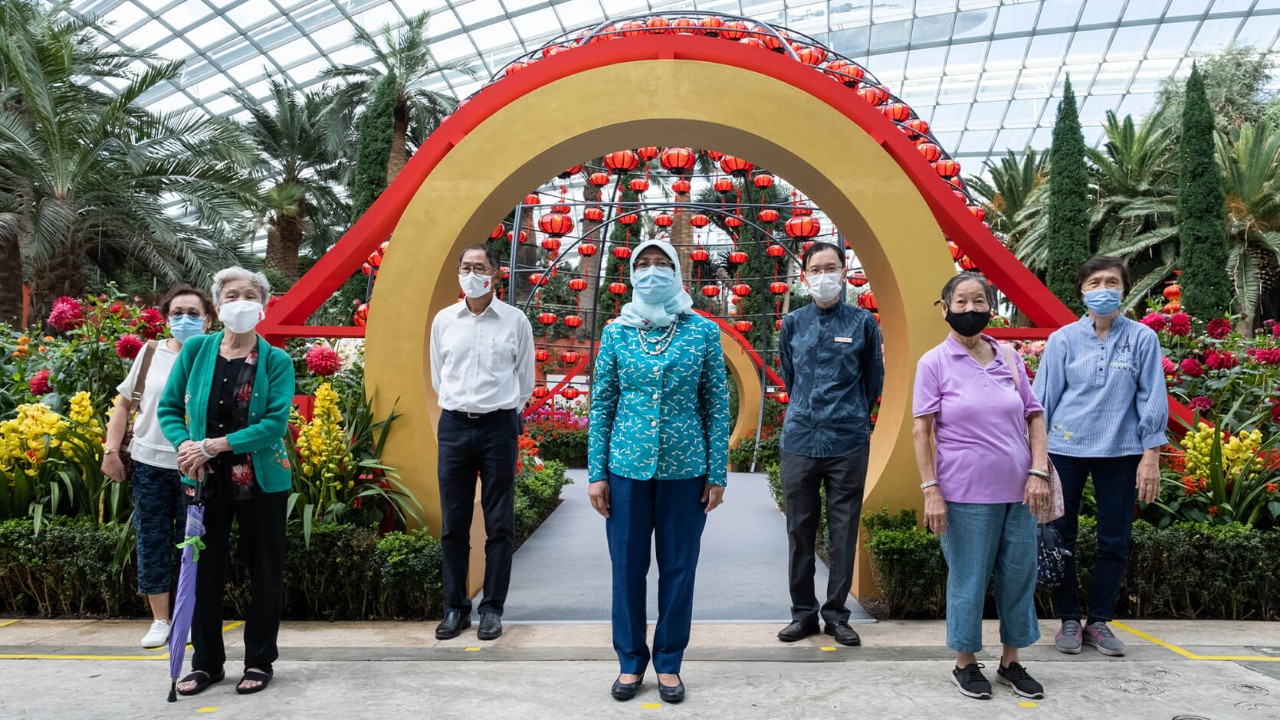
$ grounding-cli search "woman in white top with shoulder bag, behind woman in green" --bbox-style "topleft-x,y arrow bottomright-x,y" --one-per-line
102,284 -> 216,647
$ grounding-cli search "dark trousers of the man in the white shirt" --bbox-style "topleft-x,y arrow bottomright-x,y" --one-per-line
438,410 -> 521,615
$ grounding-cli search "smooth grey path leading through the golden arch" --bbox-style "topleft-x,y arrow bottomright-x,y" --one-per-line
503,470 -> 872,625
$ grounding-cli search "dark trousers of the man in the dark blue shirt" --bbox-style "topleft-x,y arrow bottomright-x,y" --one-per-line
781,446 -> 869,625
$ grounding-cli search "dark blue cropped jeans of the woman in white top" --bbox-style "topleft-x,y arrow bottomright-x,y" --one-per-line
132,461 -> 187,594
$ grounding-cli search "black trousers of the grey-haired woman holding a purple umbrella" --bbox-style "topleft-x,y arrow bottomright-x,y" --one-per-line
191,488 -> 289,675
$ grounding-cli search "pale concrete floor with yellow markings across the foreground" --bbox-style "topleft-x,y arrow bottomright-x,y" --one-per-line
0,620 -> 1280,720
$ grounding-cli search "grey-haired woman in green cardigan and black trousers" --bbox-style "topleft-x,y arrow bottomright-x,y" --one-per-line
157,268 -> 294,694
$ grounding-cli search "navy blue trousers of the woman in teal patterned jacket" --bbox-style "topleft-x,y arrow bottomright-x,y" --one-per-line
604,473 -> 707,675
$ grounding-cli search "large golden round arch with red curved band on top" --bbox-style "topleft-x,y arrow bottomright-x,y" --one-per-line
264,35 -> 1071,594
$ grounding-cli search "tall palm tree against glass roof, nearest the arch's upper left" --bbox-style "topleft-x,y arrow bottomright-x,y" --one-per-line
320,12 -> 479,183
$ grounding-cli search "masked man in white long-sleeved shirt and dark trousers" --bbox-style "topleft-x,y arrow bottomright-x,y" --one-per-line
430,245 -> 534,641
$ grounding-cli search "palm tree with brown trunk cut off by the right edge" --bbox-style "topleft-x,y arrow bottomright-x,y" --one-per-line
1217,120 -> 1280,333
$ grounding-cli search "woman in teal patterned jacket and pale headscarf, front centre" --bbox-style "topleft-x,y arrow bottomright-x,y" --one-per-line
588,241 -> 728,702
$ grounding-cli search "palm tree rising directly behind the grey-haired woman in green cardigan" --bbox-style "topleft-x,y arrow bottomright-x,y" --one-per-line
229,78 -> 347,286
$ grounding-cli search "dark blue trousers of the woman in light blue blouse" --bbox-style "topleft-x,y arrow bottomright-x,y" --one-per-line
1050,455 -> 1142,623
